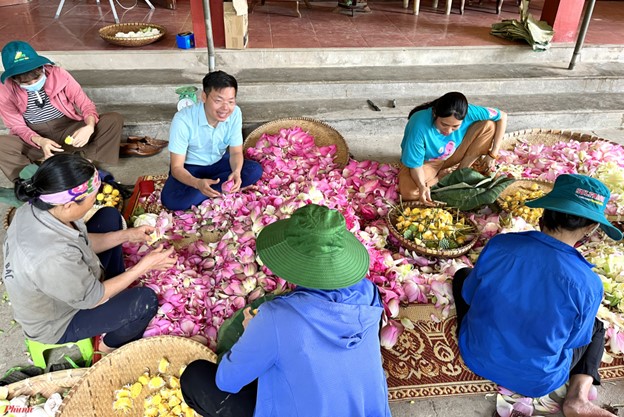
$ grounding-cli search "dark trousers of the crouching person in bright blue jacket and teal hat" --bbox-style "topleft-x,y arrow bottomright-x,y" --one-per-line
453,268 -> 605,385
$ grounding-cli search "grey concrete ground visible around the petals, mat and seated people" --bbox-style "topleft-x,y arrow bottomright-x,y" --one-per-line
0,129 -> 624,417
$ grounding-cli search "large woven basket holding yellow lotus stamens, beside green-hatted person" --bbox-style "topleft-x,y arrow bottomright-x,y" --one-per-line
58,336 -> 217,417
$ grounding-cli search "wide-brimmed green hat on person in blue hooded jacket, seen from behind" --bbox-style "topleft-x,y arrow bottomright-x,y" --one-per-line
256,204 -> 370,290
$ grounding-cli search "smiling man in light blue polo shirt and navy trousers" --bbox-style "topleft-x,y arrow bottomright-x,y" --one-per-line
160,71 -> 262,210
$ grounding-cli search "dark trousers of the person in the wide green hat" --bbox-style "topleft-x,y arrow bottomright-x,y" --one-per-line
180,360 -> 258,417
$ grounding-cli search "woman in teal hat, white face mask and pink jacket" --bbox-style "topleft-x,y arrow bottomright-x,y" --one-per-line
0,41 -> 123,181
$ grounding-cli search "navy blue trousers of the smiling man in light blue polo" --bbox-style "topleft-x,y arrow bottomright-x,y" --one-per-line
160,153 -> 262,210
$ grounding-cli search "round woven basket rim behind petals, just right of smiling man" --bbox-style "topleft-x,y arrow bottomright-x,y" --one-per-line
243,117 -> 349,167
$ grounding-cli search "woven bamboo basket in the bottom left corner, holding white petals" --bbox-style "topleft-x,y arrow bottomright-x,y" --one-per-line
6,368 -> 88,398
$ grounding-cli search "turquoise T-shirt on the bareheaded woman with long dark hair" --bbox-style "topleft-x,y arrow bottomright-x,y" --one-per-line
401,104 -> 501,168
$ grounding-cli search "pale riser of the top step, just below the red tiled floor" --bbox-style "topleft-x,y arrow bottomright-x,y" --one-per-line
37,44 -> 624,73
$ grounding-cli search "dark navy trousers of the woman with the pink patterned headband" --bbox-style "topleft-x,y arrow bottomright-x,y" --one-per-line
57,207 -> 158,348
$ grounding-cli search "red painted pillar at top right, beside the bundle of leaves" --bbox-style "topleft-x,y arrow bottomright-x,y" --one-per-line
540,0 -> 585,42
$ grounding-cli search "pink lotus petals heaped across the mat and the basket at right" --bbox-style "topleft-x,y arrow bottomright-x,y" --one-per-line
124,128 -> 624,349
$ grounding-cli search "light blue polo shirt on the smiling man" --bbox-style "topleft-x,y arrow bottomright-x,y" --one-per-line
169,103 -> 243,166
